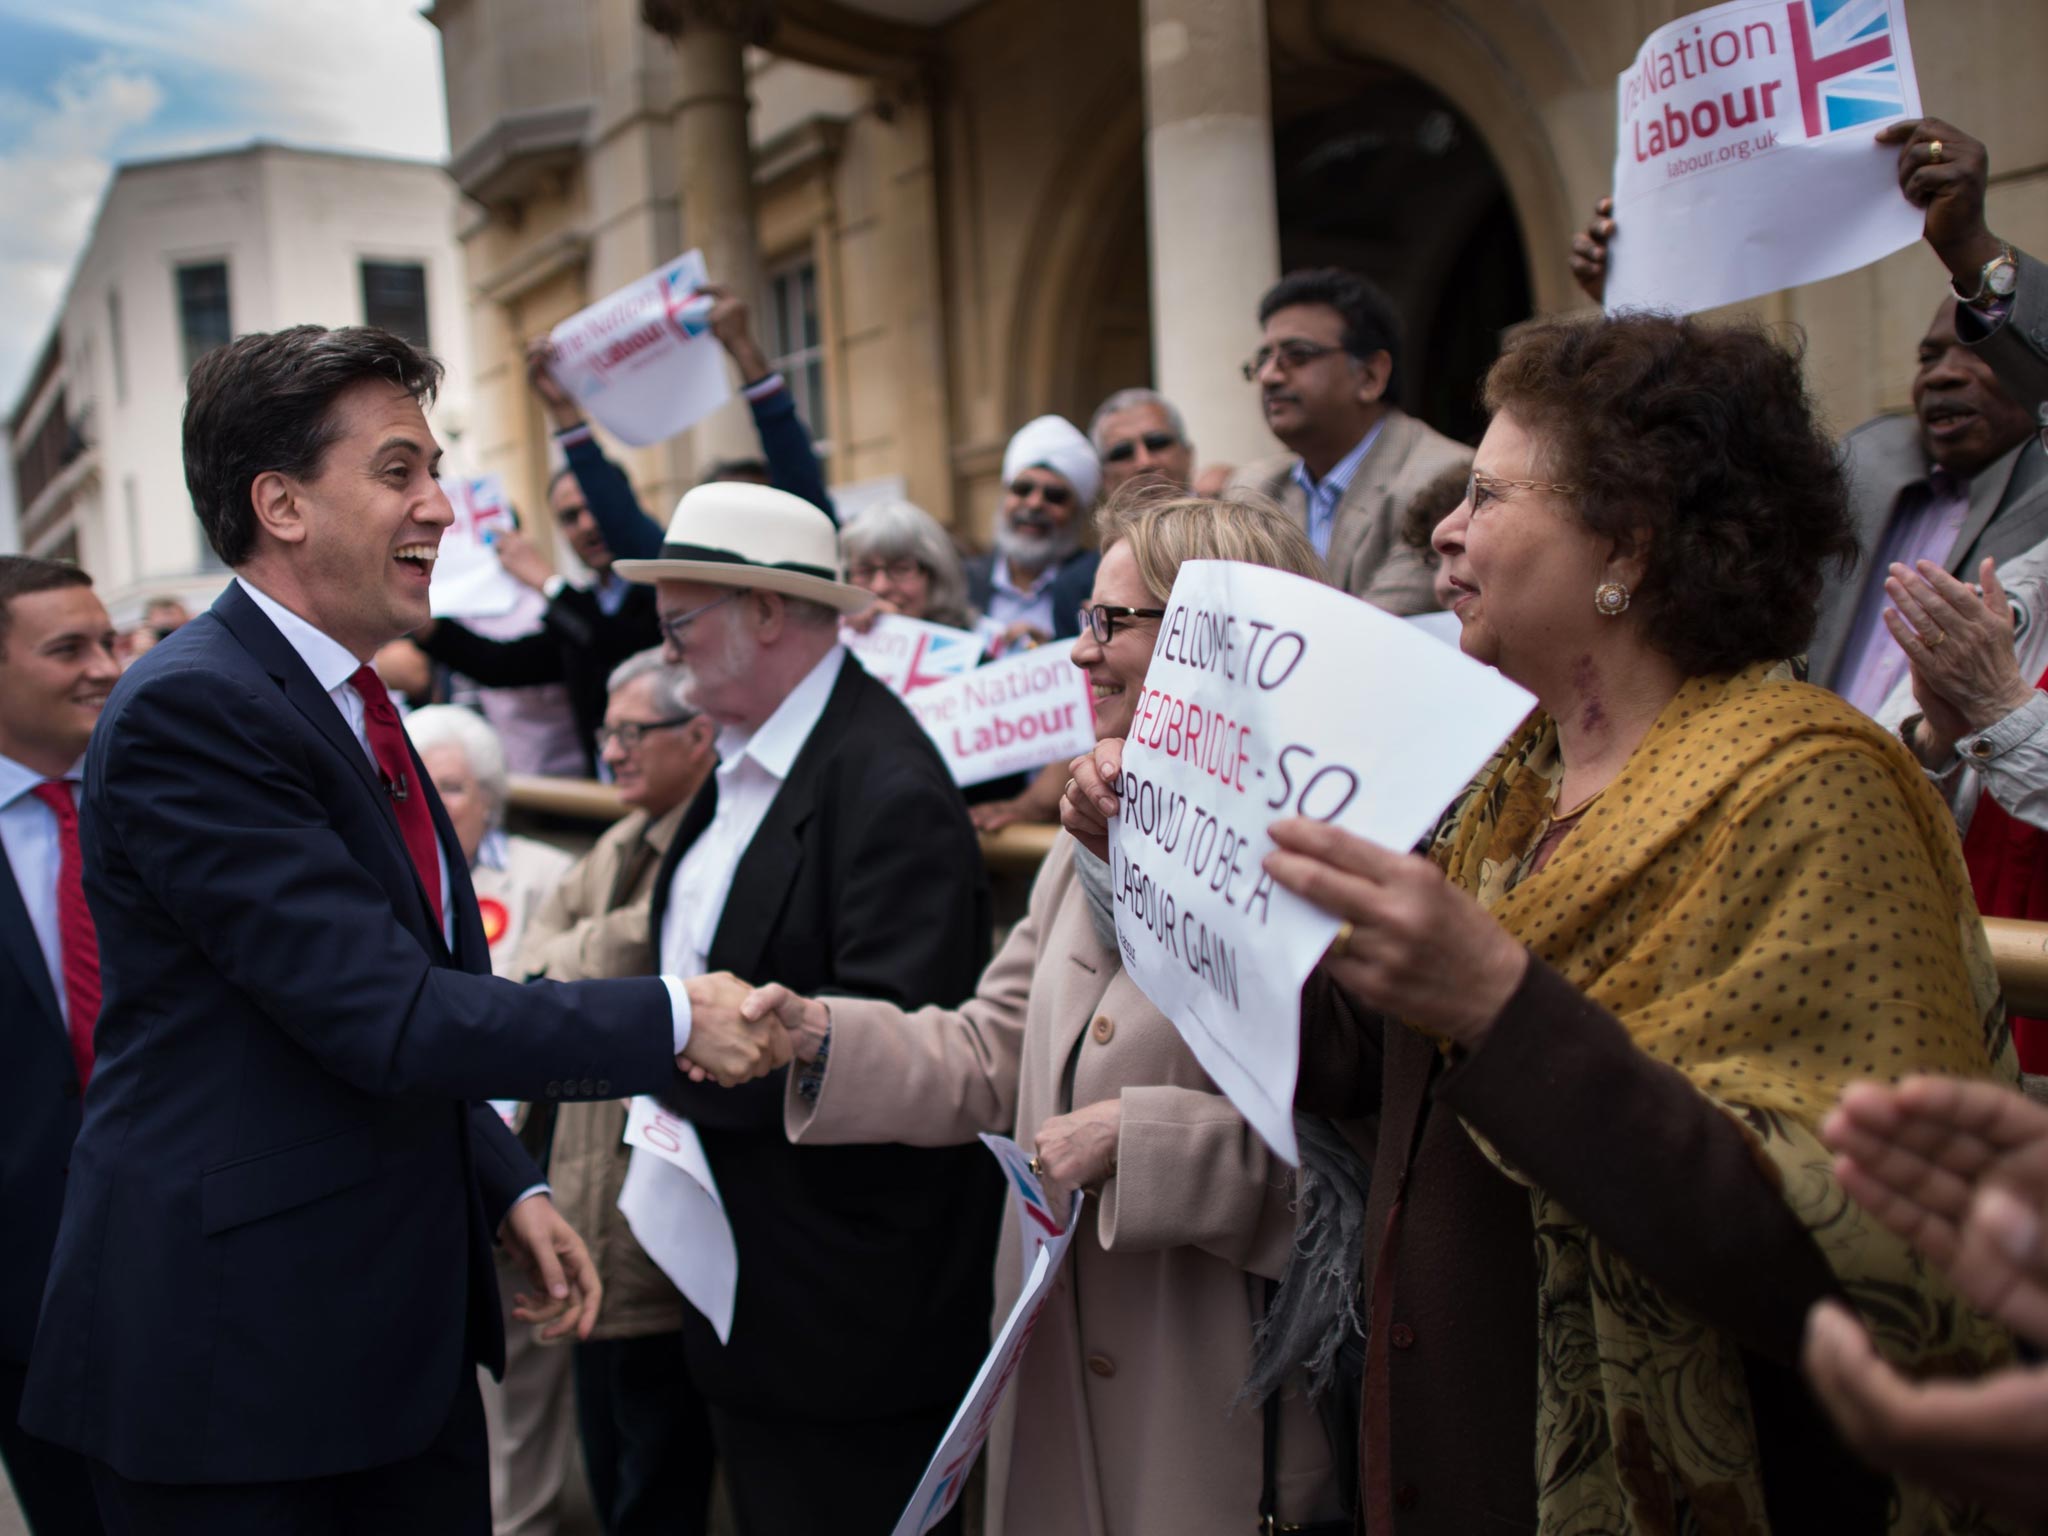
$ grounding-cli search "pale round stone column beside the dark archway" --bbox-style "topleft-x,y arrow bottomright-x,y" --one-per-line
1143,0 -> 1280,475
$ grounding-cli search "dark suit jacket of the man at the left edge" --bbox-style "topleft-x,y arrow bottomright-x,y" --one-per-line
0,848 -> 78,1364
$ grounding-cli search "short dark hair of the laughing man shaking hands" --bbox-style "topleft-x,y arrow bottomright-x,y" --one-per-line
184,326 -> 440,567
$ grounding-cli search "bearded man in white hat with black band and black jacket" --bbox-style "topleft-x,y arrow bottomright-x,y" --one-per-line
621,483 -> 1001,1536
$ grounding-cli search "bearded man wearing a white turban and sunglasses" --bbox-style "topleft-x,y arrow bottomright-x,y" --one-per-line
967,416 -> 1102,651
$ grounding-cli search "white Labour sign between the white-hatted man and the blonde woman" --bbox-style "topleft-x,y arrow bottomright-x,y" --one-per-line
903,641 -> 1096,784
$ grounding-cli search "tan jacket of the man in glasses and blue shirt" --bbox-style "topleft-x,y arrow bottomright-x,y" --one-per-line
1233,408 -> 1473,614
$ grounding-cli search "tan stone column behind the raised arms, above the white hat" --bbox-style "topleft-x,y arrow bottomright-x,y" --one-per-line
641,0 -> 774,473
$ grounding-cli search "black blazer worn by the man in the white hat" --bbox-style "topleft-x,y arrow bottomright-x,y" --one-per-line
651,657 -> 1001,1425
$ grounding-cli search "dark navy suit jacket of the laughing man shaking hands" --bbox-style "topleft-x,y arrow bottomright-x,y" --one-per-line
20,586 -> 676,1483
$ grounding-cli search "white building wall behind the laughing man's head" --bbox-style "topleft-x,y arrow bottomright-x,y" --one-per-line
39,145 -> 469,625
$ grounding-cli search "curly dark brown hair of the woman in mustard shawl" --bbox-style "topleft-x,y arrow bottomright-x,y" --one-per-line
1485,313 -> 1855,676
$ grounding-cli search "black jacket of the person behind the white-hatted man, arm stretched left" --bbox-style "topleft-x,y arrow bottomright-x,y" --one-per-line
420,584 -> 662,778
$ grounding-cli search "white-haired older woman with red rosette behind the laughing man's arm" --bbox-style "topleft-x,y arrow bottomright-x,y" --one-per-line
406,705 -> 575,1530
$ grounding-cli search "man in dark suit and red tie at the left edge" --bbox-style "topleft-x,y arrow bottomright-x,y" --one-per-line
0,555 -> 121,1536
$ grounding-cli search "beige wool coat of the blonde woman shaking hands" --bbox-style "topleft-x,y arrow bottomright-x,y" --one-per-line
786,838 -> 1350,1536
